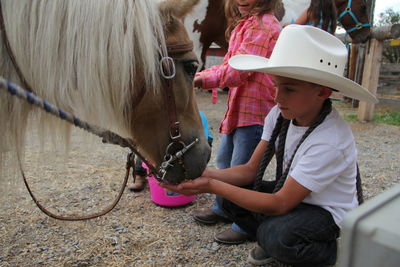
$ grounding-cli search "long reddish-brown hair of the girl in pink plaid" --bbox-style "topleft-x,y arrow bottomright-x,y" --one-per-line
224,0 -> 281,41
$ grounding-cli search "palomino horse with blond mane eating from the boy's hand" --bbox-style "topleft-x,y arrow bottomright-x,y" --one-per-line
0,0 -> 211,183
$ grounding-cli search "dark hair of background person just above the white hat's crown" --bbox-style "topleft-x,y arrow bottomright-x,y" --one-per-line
307,0 -> 337,33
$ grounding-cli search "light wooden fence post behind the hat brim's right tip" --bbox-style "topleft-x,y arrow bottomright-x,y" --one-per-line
357,38 -> 383,121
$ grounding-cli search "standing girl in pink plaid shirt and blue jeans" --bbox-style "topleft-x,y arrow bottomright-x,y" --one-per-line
194,0 -> 281,244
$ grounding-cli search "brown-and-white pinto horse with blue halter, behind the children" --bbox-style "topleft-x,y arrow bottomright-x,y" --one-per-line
184,0 -> 371,68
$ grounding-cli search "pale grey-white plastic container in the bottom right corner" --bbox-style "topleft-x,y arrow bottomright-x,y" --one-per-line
337,184 -> 400,267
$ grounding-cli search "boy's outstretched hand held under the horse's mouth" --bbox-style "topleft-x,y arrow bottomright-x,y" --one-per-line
160,177 -> 210,196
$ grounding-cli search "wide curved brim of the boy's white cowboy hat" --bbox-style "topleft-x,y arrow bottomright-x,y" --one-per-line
229,55 -> 378,103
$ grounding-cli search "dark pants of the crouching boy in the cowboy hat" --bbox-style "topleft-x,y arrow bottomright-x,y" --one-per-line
218,182 -> 339,267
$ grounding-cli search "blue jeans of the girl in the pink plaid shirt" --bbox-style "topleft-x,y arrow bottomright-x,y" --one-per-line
211,125 -> 263,234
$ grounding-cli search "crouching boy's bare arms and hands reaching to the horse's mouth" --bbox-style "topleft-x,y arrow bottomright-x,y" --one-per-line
163,140 -> 310,215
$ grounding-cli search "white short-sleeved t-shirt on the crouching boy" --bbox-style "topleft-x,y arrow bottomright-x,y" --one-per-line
262,106 -> 358,226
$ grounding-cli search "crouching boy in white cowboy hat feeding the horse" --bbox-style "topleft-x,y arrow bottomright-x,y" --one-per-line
164,25 -> 377,267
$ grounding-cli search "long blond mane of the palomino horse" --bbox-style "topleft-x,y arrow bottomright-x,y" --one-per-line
0,0 -> 166,134
